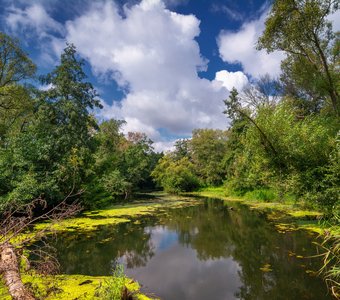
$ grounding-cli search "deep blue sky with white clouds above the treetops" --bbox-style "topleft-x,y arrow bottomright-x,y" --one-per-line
0,0 -> 340,151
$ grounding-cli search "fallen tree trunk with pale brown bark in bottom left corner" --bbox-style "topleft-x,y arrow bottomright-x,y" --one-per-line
0,243 -> 35,300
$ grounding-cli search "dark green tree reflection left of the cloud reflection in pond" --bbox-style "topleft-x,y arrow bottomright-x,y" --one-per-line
44,219 -> 154,275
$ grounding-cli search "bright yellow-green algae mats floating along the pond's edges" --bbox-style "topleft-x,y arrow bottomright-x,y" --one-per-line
0,192 -> 340,300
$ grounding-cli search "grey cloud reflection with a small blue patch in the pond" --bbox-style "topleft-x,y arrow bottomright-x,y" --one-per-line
126,226 -> 242,300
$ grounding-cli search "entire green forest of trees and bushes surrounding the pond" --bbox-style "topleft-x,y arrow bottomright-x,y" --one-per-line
0,0 -> 340,300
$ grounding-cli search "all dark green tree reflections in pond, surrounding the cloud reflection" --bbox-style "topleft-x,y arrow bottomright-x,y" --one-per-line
37,200 -> 327,299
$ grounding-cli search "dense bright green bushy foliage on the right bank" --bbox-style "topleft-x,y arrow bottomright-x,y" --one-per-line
222,95 -> 339,209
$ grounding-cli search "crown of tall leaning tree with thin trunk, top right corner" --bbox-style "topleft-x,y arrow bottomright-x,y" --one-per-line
258,0 -> 340,116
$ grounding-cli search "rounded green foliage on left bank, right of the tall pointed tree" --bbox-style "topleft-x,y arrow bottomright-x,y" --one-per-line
84,120 -> 158,206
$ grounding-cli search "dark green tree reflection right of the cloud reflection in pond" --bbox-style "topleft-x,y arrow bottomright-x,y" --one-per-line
168,200 -> 327,299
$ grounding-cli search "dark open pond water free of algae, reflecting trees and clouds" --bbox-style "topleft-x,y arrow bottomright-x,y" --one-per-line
45,200 -> 331,300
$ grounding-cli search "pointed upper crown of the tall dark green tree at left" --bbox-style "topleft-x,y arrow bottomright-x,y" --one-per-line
41,44 -> 102,151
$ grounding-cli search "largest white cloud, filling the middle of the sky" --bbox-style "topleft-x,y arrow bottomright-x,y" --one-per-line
66,0 -> 228,144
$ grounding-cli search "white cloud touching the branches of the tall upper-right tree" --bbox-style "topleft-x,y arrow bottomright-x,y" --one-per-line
217,11 -> 284,78
